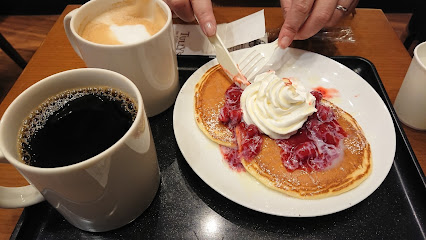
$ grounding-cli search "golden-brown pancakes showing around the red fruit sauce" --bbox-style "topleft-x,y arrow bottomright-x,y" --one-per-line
195,65 -> 372,199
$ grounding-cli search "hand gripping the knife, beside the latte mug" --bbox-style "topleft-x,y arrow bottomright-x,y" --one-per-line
164,0 -> 216,37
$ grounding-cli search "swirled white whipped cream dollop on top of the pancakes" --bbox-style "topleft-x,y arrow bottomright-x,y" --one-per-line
240,71 -> 317,139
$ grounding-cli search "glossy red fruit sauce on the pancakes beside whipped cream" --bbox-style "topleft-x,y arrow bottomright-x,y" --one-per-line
219,84 -> 347,172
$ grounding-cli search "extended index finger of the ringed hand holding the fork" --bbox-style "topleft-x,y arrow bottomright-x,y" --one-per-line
278,0 -> 316,48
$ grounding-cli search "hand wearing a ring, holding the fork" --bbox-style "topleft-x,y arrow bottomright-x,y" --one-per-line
278,0 -> 359,48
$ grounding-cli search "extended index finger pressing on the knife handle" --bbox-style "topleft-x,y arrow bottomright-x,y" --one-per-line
191,0 -> 216,37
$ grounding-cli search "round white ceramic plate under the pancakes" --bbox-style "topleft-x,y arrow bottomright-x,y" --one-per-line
173,49 -> 396,217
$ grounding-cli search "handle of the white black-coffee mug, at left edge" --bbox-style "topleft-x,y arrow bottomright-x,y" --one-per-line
0,151 -> 44,208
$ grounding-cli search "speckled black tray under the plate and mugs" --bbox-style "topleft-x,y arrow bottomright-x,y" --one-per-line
11,57 -> 426,239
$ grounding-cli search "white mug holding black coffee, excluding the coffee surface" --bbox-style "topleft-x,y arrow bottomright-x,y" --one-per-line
0,68 -> 160,232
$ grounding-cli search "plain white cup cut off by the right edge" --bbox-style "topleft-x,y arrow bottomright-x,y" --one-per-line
394,42 -> 426,130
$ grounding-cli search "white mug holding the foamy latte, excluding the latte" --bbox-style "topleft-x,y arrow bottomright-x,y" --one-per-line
64,0 -> 179,117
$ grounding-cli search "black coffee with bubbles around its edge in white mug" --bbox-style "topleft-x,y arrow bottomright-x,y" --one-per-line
18,87 -> 137,168
